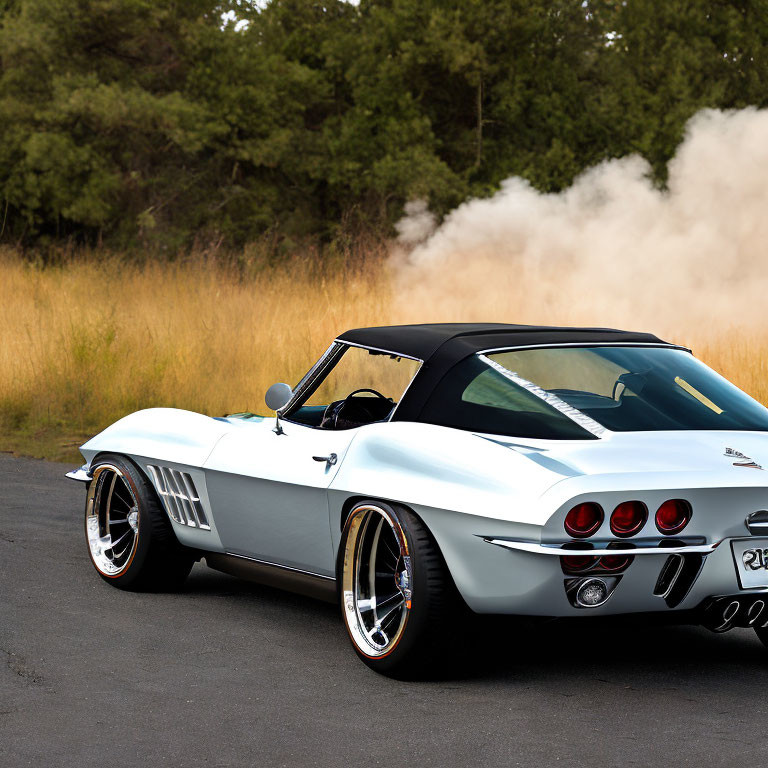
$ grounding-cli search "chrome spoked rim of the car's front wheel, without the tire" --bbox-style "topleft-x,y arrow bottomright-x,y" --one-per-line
85,464 -> 139,577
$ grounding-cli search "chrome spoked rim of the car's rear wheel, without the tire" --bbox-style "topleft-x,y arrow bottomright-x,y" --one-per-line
342,505 -> 413,657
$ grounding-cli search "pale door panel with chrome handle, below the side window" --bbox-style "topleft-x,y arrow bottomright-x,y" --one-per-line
204,419 -> 357,576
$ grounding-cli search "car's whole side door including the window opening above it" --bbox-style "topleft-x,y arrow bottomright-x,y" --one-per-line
204,342 -> 420,576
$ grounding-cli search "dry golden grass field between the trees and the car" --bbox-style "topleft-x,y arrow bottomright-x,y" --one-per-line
0,251 -> 768,461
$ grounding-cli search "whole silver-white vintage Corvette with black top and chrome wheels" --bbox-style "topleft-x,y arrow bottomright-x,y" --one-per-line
69,324 -> 768,675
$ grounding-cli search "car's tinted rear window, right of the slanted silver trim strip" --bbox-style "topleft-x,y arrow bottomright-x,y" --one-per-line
487,346 -> 768,432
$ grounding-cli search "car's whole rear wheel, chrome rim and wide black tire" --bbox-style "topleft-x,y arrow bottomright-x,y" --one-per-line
340,501 -> 461,678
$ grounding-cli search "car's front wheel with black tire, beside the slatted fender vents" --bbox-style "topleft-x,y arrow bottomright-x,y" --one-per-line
85,454 -> 195,592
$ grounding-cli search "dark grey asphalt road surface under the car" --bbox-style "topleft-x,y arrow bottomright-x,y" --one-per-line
0,455 -> 768,768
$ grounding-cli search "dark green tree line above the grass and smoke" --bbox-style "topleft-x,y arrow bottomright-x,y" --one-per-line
0,0 -> 768,250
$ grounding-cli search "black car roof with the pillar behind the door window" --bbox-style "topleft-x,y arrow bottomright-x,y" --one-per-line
338,323 -> 672,421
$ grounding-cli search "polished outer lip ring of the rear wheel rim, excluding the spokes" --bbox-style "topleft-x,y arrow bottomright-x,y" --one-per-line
341,503 -> 413,659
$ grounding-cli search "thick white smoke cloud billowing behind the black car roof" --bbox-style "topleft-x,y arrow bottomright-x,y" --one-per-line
392,108 -> 768,341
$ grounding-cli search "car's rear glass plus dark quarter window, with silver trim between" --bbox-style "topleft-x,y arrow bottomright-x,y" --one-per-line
421,346 -> 768,440
